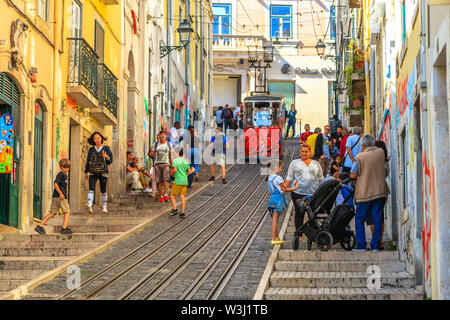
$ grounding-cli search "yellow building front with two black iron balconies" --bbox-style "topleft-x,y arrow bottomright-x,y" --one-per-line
56,0 -> 121,211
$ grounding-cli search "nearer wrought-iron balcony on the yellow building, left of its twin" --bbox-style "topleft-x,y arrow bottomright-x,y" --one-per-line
67,38 -> 98,108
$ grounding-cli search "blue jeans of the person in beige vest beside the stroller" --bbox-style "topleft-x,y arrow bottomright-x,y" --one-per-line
355,198 -> 386,249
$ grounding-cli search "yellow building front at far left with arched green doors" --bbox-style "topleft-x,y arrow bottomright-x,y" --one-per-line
0,0 -> 55,228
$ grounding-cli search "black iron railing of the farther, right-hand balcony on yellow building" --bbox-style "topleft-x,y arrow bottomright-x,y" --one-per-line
98,63 -> 117,118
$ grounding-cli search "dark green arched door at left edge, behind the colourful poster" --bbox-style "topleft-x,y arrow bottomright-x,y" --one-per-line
0,73 -> 20,228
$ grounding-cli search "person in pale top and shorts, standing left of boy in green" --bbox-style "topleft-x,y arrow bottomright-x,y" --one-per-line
152,130 -> 173,202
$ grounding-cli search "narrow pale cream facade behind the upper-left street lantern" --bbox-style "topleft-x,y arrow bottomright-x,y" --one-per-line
161,0 -> 213,129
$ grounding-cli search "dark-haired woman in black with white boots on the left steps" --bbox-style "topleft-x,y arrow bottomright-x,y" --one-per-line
84,131 -> 113,213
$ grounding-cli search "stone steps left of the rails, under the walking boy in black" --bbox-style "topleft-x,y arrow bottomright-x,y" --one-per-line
0,166 -> 225,300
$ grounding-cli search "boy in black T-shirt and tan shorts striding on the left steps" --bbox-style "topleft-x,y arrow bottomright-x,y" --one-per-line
34,159 -> 72,234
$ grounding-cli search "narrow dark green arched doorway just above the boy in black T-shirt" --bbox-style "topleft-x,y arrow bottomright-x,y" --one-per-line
33,101 -> 44,219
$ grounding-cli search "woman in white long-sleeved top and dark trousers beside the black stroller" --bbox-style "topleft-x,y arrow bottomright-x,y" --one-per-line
284,144 -> 323,241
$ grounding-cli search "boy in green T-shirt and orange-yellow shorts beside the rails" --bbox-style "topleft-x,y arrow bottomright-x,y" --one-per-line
170,148 -> 195,218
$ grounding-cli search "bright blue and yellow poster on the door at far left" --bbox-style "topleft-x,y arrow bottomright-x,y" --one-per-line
0,113 -> 14,174
